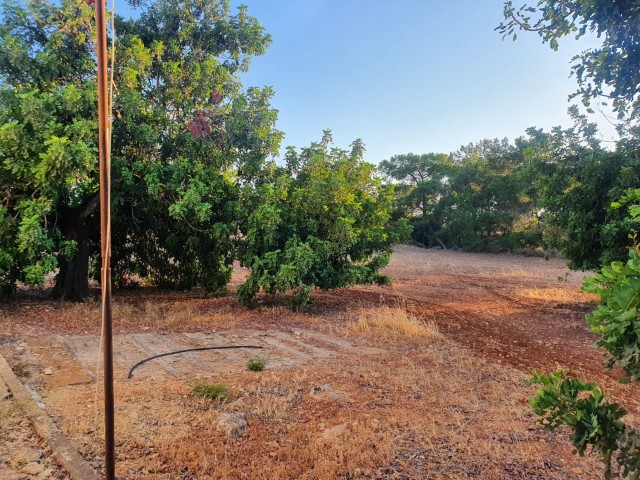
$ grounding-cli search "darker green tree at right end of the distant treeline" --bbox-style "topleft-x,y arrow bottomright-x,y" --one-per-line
517,119 -> 640,270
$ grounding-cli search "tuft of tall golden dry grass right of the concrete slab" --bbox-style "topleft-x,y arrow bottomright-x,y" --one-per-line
344,306 -> 439,338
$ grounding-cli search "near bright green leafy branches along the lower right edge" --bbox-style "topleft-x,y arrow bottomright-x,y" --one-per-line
530,193 -> 640,479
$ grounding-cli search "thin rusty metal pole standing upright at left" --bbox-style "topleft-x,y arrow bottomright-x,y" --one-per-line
95,0 -> 115,480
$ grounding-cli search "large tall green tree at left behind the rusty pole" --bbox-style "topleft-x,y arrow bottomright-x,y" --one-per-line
0,0 -> 282,299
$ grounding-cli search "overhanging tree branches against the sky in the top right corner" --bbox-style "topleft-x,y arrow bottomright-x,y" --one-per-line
496,0 -> 640,116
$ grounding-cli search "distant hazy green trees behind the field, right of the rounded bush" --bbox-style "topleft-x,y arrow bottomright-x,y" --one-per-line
380,139 -> 540,251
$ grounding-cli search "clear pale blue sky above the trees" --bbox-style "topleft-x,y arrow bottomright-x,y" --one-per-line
232,0 -> 613,163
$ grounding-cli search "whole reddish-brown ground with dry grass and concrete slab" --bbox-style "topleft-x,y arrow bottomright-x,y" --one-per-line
0,246 -> 640,479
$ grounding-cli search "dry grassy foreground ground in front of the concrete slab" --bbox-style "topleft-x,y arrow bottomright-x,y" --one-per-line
49,332 -> 600,480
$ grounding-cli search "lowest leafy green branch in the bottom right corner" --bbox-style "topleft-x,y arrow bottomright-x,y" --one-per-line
529,370 -> 640,479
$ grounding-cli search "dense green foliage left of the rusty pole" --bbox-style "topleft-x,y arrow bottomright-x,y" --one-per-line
0,1 -> 97,297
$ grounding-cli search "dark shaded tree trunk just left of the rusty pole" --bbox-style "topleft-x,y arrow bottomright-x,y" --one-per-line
52,196 -> 98,301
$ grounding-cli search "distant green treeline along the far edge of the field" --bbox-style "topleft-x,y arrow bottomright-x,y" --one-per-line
380,109 -> 640,269
